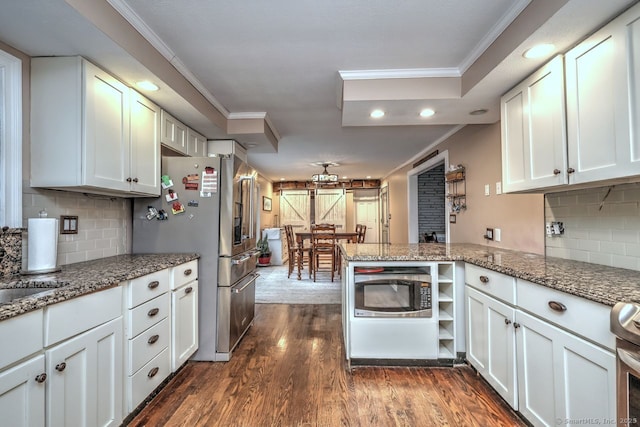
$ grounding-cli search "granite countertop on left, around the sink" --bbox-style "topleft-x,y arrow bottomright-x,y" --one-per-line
0,253 -> 199,321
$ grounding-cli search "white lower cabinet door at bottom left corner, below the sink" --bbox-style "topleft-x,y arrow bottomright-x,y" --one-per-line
0,355 -> 45,427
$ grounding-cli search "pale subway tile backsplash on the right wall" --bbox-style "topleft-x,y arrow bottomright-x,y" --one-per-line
545,183 -> 640,270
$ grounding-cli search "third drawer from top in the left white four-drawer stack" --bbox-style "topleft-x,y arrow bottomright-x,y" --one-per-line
127,317 -> 171,375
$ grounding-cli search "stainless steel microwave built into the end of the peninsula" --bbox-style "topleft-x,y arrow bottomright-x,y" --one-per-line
354,267 -> 433,317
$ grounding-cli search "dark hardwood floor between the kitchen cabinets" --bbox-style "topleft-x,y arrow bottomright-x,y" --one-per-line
129,304 -> 525,427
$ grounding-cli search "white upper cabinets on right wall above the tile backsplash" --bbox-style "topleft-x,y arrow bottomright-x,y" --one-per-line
501,5 -> 640,192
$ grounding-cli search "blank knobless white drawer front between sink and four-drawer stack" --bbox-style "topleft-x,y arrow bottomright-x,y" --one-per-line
44,286 -> 122,347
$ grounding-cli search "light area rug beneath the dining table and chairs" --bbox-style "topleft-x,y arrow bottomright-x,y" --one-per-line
256,265 -> 342,304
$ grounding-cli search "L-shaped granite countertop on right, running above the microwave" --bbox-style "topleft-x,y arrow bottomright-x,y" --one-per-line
341,243 -> 640,306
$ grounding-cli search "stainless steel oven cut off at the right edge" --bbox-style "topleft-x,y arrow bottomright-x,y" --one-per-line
611,302 -> 640,426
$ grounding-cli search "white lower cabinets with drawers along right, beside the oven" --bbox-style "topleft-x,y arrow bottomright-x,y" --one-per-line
465,266 -> 616,426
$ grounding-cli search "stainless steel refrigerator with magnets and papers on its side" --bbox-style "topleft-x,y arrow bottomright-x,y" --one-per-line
133,155 -> 258,361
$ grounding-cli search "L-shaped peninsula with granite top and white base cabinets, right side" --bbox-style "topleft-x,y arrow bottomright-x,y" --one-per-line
341,243 -> 640,425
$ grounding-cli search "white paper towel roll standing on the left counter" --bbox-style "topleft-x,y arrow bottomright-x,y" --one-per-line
27,218 -> 58,273
